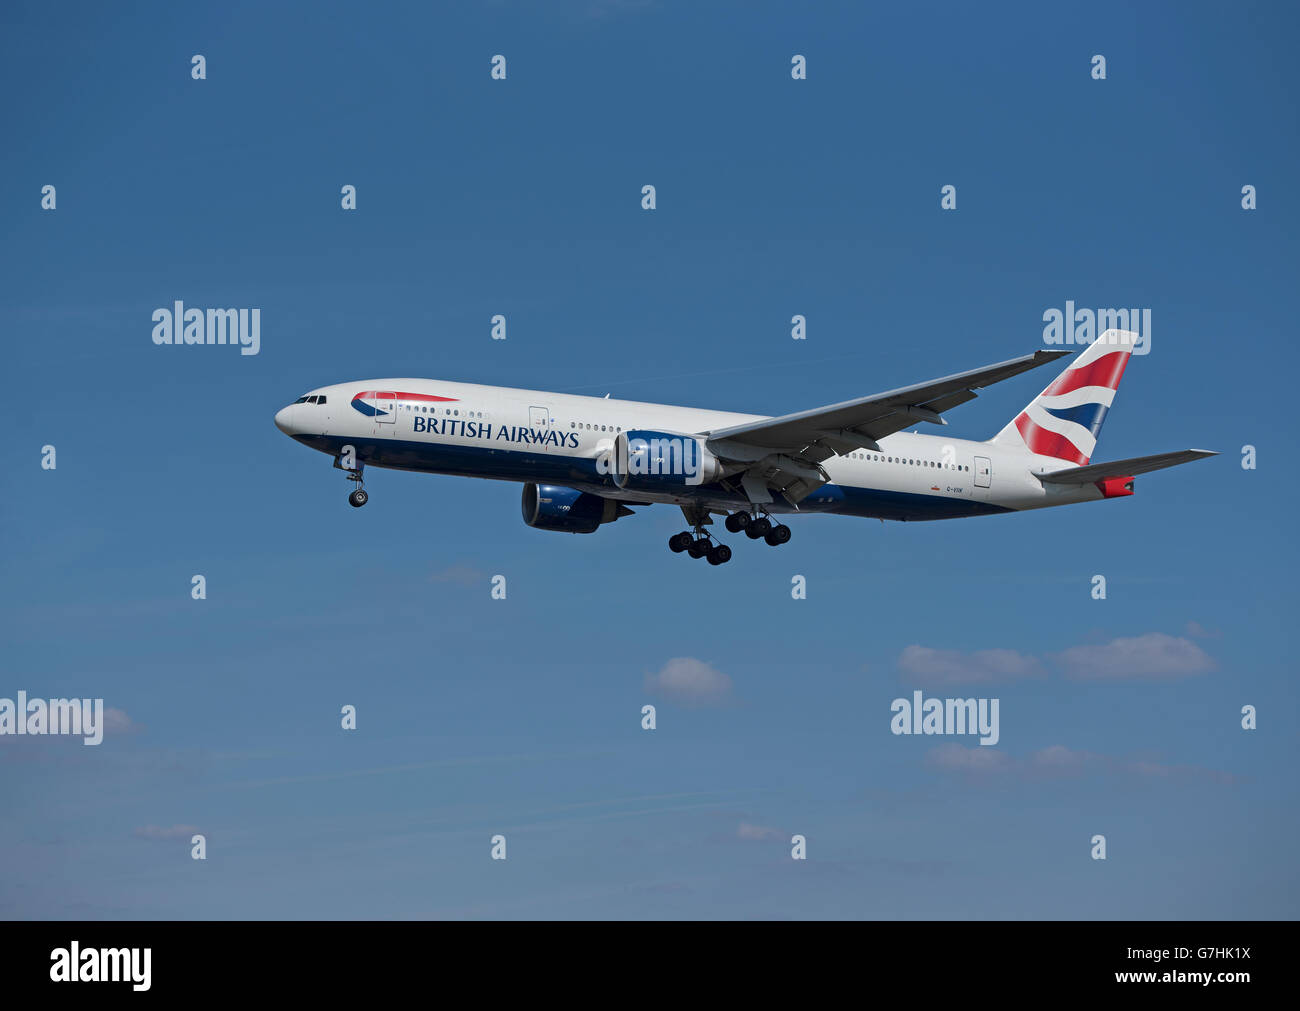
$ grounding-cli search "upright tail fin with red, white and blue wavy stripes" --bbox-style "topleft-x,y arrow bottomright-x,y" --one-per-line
989,330 -> 1138,465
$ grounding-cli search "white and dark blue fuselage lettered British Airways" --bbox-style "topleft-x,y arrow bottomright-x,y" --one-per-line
276,378 -> 1102,520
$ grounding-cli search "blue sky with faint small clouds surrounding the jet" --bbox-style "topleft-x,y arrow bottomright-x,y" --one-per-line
0,0 -> 1300,919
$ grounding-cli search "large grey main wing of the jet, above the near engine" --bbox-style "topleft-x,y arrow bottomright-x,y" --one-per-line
699,350 -> 1071,503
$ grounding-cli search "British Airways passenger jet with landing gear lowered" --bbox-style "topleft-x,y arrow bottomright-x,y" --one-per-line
276,330 -> 1217,565
